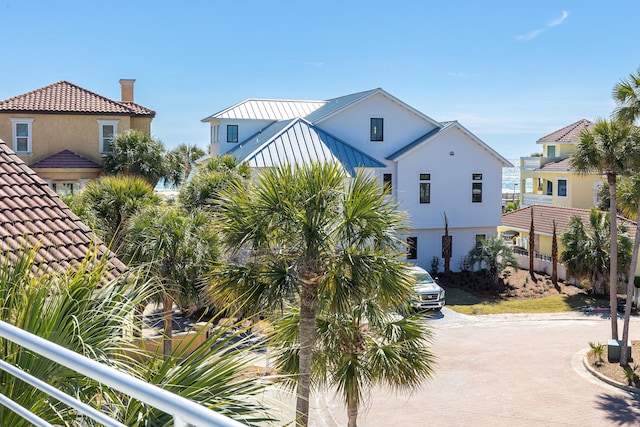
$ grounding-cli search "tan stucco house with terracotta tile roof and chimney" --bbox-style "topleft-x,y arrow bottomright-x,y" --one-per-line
0,79 -> 156,194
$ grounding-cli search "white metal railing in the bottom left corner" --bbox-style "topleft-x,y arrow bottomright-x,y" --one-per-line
0,321 -> 243,427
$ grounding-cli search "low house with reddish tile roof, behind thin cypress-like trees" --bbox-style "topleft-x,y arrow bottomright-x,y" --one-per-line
498,205 -> 640,279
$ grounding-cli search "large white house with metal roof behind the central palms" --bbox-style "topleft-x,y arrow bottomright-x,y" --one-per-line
202,88 -> 512,271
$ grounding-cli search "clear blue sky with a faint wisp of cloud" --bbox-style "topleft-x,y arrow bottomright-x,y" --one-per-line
0,0 -> 640,158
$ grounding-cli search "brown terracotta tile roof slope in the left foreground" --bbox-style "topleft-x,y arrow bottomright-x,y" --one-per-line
0,140 -> 126,280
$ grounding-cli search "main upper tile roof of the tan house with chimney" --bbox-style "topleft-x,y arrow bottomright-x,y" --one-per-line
0,80 -> 156,117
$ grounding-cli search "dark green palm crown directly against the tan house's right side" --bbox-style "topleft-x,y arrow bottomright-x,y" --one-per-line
104,130 -> 185,187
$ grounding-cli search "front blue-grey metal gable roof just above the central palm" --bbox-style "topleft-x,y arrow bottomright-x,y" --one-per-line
228,118 -> 385,176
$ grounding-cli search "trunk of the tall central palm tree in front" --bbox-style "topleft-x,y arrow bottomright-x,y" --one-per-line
296,280 -> 319,427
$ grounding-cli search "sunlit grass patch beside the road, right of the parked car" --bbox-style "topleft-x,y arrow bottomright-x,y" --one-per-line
447,288 -> 609,315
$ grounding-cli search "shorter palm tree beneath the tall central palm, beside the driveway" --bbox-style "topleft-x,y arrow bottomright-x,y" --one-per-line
274,298 -> 435,427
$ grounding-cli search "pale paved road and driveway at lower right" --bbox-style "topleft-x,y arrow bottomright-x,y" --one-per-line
264,309 -> 640,427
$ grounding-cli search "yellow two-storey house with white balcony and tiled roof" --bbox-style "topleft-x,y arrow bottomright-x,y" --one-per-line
520,119 -> 605,209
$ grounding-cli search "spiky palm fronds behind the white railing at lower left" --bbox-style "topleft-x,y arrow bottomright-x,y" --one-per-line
0,248 -> 269,427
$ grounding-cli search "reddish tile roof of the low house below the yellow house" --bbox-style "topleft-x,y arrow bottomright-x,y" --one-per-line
502,205 -> 636,238
